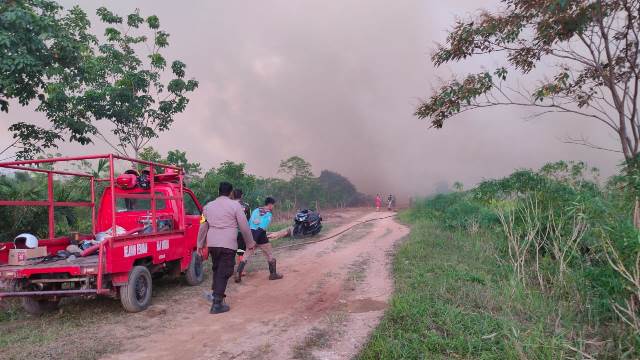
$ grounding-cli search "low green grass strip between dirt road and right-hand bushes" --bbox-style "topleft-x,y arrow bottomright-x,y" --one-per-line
358,213 -> 608,359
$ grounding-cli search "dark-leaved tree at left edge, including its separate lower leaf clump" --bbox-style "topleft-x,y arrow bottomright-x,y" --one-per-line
0,0 -> 96,158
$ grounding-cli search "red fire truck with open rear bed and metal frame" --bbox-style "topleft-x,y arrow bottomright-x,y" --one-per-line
0,154 -> 206,314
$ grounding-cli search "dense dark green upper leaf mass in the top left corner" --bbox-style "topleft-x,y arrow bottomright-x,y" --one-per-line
0,0 -> 95,112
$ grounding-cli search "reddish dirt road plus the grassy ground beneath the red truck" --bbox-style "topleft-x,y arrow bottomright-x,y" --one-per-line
0,209 -> 408,360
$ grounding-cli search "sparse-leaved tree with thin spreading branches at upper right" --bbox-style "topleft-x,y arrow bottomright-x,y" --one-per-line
415,0 -> 640,161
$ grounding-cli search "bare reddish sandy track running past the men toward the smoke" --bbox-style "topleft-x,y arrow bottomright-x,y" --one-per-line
108,212 -> 408,359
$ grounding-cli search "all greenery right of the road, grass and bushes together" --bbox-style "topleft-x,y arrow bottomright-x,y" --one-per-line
376,161 -> 640,358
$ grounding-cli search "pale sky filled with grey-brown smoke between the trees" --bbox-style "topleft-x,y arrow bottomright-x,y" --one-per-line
0,0 -> 619,196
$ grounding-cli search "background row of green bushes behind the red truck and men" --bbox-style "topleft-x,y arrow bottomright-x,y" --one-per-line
0,152 -> 368,242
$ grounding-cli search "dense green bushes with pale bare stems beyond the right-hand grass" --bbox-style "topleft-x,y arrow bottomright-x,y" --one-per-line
406,161 -> 640,358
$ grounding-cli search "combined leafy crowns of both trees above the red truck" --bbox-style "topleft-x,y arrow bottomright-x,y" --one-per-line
0,0 -> 198,158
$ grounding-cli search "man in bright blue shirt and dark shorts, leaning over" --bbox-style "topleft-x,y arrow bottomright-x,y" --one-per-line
235,197 -> 282,283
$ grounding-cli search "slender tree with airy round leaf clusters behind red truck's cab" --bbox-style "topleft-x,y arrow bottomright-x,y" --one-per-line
39,7 -> 198,157
